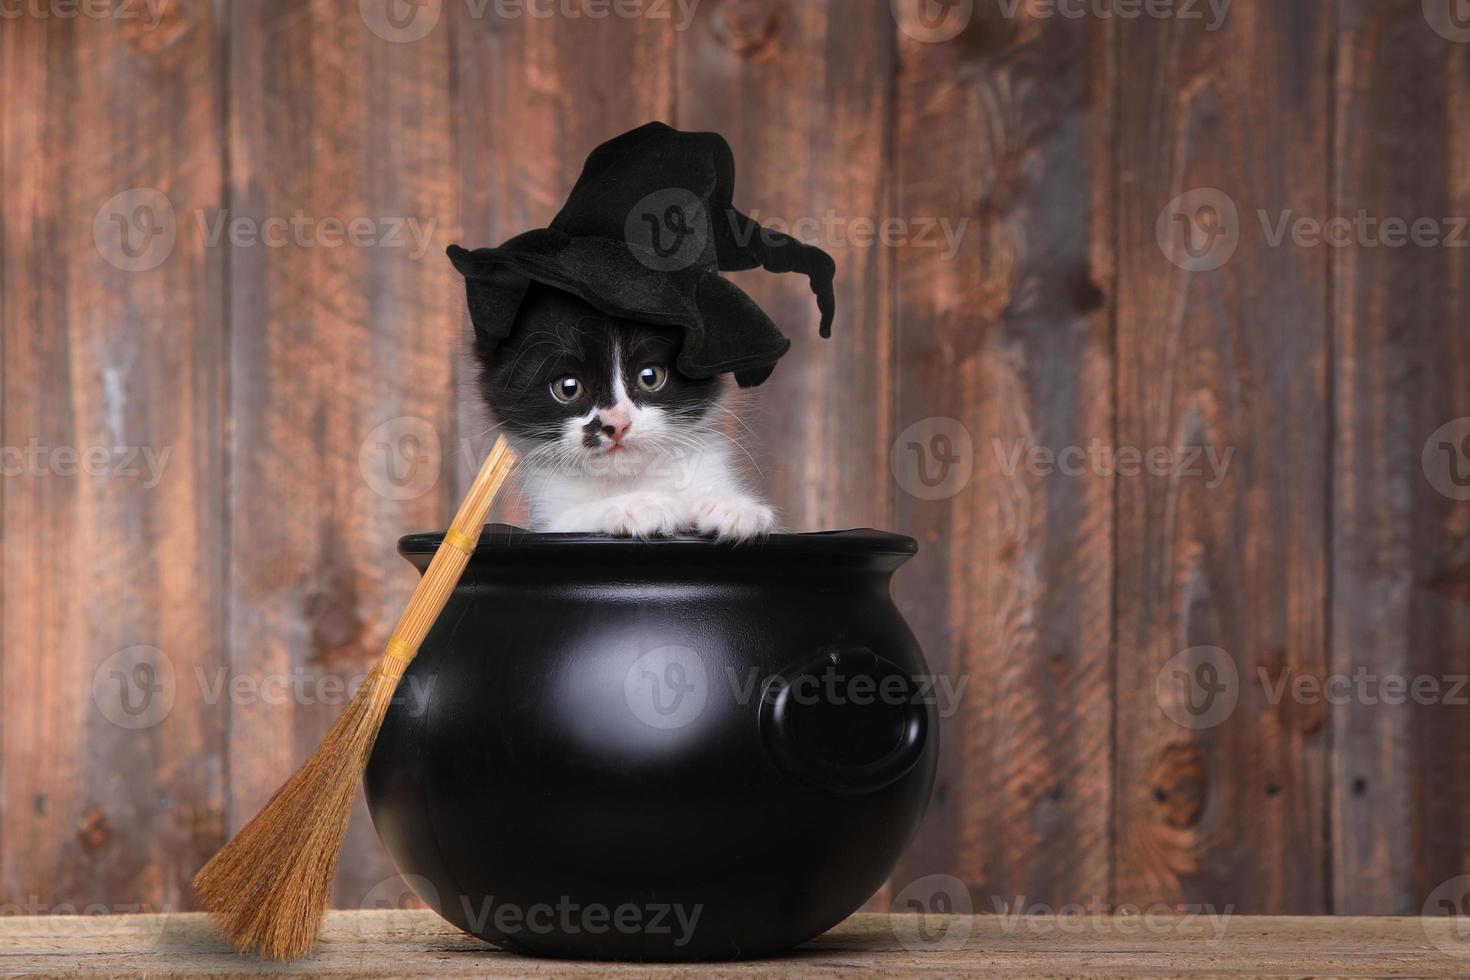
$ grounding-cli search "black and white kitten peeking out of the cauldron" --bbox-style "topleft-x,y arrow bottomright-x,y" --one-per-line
481,285 -> 775,541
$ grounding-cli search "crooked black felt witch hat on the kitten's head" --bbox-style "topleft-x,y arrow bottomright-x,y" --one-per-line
448,122 -> 836,388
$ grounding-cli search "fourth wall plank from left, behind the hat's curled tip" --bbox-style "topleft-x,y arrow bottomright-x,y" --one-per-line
678,0 -> 895,530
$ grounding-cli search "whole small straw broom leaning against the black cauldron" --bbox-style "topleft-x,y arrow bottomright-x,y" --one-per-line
194,438 -> 516,959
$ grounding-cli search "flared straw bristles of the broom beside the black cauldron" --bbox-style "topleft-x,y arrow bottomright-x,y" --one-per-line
194,658 -> 398,959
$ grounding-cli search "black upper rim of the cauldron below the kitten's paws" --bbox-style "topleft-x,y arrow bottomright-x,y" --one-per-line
398,525 -> 919,564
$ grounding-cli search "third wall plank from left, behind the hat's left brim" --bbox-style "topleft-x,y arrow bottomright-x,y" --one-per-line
445,3 -> 684,523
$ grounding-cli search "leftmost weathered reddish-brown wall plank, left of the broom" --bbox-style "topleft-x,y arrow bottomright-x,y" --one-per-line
0,0 -> 223,912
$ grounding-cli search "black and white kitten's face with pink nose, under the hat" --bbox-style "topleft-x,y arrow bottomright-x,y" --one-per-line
484,288 -> 722,475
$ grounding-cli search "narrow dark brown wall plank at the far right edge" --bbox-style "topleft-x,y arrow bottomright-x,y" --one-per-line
1332,0 -> 1470,912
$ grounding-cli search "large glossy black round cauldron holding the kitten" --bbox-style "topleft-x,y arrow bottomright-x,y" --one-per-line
366,525 -> 938,959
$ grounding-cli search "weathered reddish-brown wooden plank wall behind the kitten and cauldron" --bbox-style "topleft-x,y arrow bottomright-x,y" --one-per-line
0,0 -> 1470,914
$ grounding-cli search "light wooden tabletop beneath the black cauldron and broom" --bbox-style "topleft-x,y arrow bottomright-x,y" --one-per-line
0,909 -> 1470,977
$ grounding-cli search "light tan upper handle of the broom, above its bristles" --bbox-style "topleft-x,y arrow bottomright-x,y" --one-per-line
382,436 -> 516,677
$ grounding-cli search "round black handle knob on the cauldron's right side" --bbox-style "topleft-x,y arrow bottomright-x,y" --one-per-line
760,646 -> 931,795
